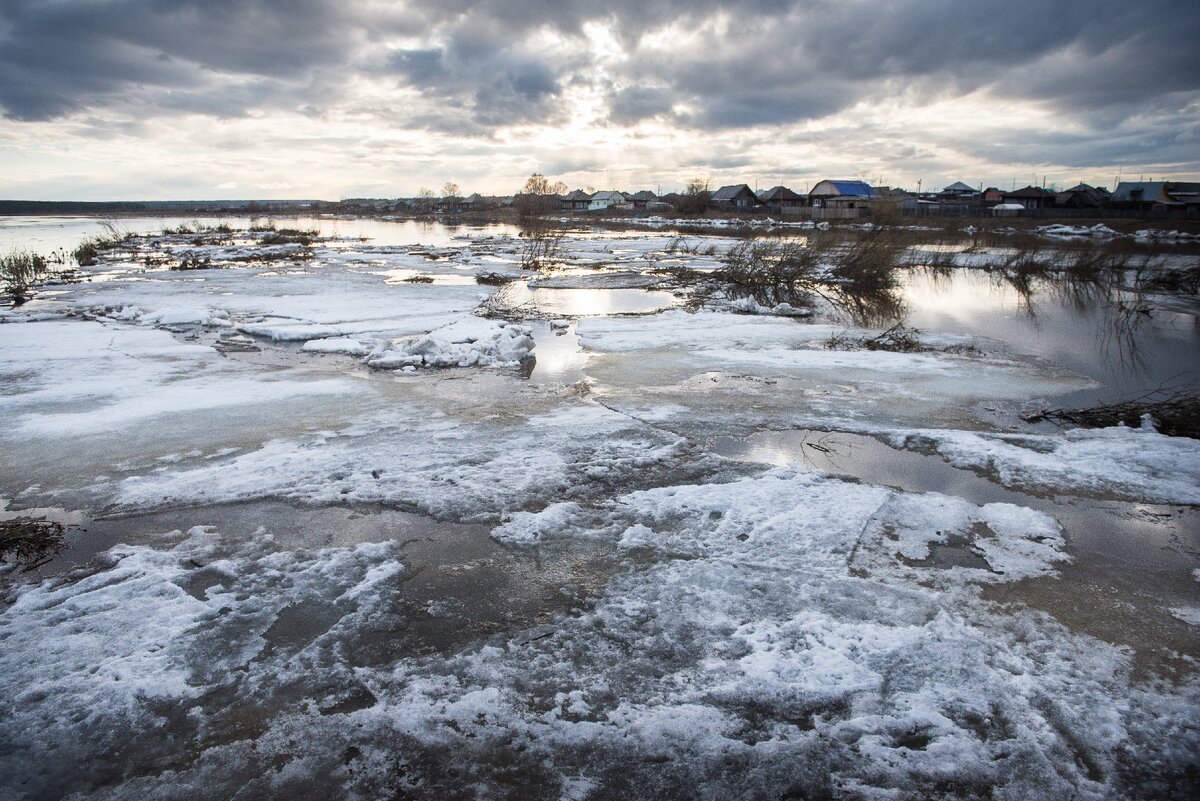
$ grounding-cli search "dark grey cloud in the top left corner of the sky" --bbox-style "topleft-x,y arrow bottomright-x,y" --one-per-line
0,0 -> 372,120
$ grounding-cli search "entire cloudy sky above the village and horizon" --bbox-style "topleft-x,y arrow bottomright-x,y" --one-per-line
0,0 -> 1200,200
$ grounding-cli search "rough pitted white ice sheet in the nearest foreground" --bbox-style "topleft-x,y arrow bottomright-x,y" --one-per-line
0,470 -> 1200,799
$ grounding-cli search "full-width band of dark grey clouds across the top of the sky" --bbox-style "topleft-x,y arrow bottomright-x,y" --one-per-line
0,0 -> 1200,136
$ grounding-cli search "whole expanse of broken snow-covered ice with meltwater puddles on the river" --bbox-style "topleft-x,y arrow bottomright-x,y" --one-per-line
0,219 -> 1200,801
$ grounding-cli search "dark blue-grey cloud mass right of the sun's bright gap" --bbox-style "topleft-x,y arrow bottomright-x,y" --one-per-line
613,0 -> 1200,127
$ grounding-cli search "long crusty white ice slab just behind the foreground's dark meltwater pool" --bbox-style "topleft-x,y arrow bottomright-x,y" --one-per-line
114,401 -> 720,520
